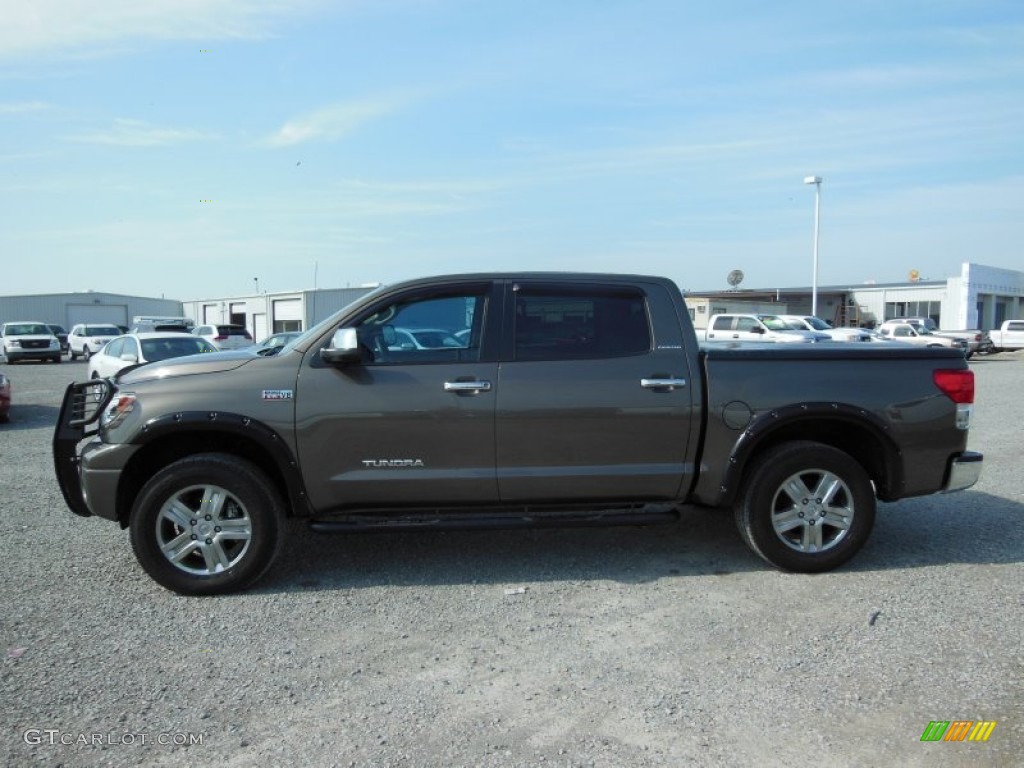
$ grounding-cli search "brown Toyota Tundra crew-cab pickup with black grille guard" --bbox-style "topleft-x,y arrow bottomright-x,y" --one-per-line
53,273 -> 982,594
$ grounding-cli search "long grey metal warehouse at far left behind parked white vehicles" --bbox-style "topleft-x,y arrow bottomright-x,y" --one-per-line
0,291 -> 181,329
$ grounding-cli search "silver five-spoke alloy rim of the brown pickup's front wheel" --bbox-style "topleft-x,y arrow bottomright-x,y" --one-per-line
157,485 -> 252,575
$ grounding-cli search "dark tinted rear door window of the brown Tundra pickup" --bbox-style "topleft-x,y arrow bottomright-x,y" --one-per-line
515,288 -> 651,360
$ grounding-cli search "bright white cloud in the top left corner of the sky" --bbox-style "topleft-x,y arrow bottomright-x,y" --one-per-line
0,0 -> 321,57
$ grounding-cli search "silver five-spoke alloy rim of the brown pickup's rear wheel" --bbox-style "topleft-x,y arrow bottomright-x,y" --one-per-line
771,469 -> 855,552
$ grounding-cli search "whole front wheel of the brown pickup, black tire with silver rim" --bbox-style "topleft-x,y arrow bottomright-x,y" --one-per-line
129,454 -> 285,595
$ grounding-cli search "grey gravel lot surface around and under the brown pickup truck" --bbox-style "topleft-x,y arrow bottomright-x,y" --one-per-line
0,353 -> 1024,767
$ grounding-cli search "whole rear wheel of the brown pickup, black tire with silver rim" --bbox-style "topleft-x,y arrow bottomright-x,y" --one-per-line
735,441 -> 874,573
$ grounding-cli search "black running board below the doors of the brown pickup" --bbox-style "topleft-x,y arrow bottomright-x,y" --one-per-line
309,504 -> 679,534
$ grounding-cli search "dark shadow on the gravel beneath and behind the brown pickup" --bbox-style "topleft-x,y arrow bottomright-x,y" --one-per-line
264,493 -> 1024,593
